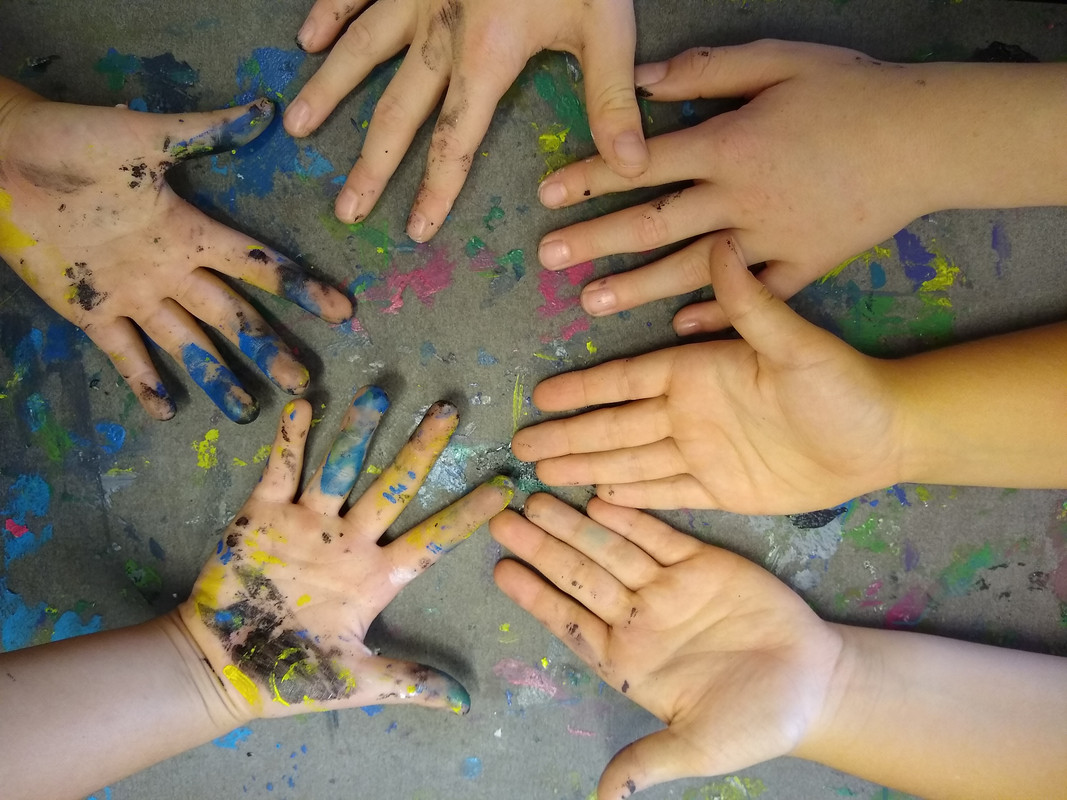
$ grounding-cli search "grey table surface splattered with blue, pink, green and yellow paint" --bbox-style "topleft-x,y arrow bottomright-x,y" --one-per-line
0,0 -> 1067,800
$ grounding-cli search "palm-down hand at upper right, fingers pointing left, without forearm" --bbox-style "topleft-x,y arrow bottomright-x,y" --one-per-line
539,41 -> 952,335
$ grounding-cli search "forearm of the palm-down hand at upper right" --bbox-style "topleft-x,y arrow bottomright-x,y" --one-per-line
896,63 -> 1067,211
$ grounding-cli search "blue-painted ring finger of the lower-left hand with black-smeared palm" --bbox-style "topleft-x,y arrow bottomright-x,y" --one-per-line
300,386 -> 389,515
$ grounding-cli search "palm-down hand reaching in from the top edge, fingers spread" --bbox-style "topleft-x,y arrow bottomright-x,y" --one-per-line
285,0 -> 648,242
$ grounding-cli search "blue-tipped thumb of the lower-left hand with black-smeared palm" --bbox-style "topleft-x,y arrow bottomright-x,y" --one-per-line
354,656 -> 471,714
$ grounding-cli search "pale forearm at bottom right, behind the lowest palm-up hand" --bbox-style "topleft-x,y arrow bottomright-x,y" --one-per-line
793,625 -> 1067,800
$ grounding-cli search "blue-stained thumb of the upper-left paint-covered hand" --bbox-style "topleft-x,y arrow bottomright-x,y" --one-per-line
154,97 -> 274,165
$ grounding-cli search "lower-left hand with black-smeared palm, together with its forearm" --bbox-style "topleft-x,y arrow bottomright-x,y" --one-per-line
0,386 -> 514,800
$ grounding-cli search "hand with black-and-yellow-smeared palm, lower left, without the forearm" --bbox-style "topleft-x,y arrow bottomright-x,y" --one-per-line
179,387 -> 514,719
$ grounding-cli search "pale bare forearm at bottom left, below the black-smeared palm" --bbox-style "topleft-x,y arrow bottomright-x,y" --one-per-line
0,612 -> 246,800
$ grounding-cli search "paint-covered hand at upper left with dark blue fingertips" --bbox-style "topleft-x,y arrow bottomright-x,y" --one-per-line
0,79 -> 352,422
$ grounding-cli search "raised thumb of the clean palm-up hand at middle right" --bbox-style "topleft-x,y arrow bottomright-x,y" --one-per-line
707,236 -> 819,358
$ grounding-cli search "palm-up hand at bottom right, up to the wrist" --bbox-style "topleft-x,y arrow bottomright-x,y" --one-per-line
490,495 -> 842,800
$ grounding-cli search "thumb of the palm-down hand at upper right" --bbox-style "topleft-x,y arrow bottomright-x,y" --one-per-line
634,39 -> 800,101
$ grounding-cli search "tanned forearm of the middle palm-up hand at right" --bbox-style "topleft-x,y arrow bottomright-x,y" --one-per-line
886,323 -> 1067,489
